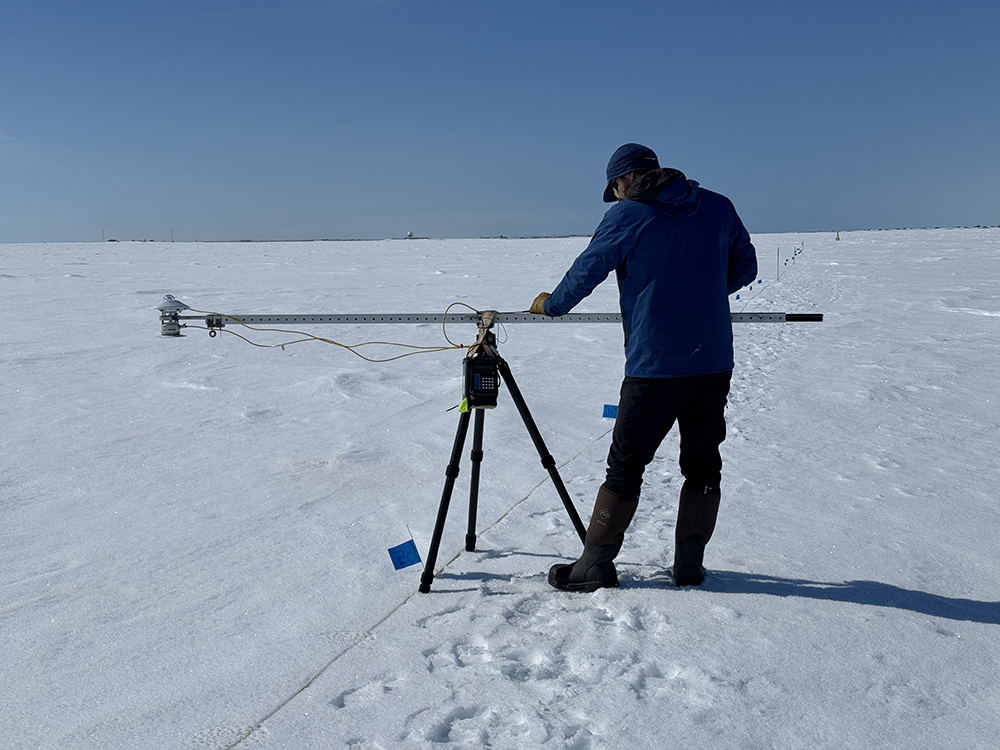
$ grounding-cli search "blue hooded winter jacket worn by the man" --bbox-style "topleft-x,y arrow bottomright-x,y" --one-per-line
545,169 -> 757,378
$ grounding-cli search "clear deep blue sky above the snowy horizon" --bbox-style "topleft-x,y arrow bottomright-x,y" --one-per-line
0,0 -> 1000,243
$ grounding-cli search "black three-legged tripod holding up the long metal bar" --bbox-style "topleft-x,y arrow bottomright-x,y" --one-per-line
420,313 -> 587,594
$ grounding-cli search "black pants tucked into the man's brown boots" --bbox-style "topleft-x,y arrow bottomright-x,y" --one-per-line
604,371 -> 733,499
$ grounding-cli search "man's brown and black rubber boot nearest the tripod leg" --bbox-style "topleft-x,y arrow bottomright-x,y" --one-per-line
549,485 -> 639,591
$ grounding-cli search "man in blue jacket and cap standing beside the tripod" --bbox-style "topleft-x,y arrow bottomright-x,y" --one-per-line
531,143 -> 757,591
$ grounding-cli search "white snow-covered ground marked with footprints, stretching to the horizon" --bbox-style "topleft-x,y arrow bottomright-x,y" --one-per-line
0,229 -> 1000,750
